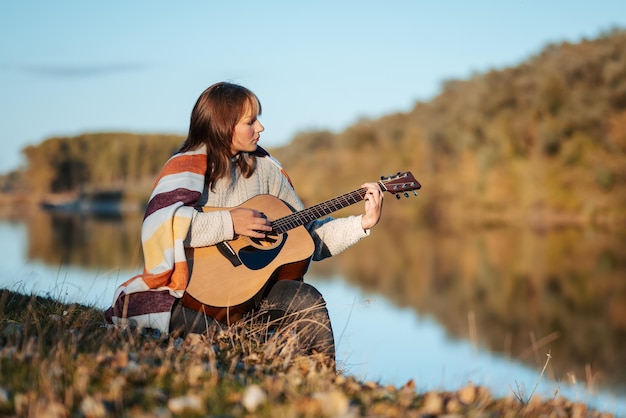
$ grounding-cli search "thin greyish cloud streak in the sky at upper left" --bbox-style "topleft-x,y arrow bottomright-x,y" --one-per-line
0,63 -> 148,78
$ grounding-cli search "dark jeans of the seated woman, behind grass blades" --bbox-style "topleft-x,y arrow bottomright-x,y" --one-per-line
170,280 -> 335,364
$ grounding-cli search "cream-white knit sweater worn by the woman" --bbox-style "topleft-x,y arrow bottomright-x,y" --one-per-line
186,157 -> 369,261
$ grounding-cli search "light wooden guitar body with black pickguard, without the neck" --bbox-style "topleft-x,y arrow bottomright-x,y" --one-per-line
186,195 -> 314,322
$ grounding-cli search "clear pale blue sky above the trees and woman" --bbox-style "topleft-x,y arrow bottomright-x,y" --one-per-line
0,0 -> 626,173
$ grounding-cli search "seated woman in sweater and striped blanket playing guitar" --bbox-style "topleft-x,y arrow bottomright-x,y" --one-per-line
107,82 -> 383,361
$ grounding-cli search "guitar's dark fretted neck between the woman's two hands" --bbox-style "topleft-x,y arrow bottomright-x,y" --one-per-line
272,187 -> 367,234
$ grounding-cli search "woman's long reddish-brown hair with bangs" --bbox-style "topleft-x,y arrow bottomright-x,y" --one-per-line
179,82 -> 261,188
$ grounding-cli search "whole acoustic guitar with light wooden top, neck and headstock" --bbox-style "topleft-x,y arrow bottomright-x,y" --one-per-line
183,172 -> 422,322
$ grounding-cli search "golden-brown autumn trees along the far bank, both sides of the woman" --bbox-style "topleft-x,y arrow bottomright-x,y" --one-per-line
4,30 -> 626,226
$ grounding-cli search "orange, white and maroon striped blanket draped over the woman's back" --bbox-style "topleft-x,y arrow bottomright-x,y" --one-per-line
105,147 -> 207,334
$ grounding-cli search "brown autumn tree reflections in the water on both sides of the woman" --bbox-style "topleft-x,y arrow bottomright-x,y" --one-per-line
2,212 -> 626,406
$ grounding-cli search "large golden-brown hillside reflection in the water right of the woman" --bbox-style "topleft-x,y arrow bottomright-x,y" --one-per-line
328,222 -> 626,387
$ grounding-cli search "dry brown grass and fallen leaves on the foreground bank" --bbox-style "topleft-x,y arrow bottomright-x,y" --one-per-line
0,290 -> 610,417
